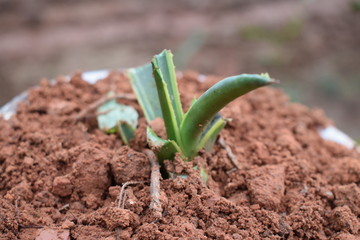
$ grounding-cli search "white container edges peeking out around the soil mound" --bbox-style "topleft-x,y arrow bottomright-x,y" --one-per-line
0,70 -> 356,149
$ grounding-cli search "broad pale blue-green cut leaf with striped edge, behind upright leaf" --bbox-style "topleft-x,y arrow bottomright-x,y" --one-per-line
128,63 -> 162,122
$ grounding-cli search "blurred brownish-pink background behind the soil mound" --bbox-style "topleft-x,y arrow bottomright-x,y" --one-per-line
0,0 -> 360,140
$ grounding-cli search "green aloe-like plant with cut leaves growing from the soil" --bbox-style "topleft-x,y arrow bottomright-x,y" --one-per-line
129,50 -> 275,161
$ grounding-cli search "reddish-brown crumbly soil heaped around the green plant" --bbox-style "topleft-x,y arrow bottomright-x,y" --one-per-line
0,72 -> 360,240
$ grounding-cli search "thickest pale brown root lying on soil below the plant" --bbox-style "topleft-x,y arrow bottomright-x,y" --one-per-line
144,149 -> 163,219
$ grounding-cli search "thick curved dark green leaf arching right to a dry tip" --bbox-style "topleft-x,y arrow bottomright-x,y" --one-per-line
180,74 -> 275,157
